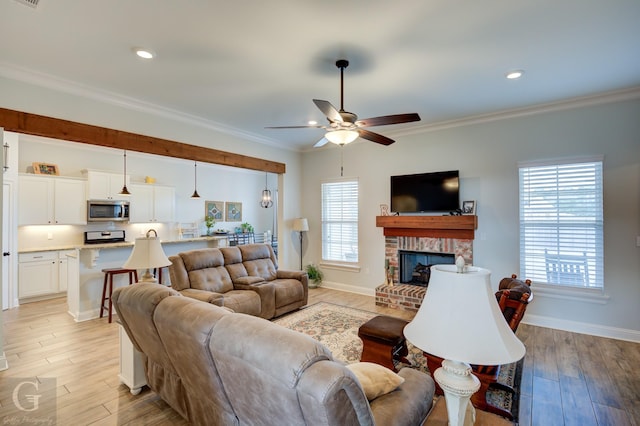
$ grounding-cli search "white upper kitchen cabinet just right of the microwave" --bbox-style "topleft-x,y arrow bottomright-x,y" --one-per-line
129,184 -> 175,223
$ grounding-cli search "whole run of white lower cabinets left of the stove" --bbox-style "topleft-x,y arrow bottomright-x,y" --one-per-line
18,249 -> 80,299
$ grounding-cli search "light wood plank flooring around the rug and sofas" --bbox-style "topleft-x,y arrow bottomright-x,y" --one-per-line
0,288 -> 640,426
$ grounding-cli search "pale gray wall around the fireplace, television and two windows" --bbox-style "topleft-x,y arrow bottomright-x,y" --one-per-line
302,95 -> 640,340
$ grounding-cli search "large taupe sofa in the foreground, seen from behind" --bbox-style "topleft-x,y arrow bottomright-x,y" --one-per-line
113,283 -> 434,426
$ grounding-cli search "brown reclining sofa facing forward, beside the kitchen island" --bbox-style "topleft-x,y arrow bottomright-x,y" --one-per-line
169,244 -> 309,319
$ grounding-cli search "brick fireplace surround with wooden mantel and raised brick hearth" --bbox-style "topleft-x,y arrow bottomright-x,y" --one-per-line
375,216 -> 477,312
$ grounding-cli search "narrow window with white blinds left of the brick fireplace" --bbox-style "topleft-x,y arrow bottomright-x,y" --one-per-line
322,179 -> 358,263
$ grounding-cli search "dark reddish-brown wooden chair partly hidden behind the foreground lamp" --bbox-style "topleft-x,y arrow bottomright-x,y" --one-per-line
424,274 -> 533,420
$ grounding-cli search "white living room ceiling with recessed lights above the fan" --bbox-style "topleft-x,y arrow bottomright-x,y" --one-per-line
0,0 -> 640,149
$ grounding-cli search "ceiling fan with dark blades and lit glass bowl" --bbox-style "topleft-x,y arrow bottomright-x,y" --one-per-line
266,59 -> 420,147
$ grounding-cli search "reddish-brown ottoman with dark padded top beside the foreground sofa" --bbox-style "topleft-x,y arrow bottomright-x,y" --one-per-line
358,315 -> 409,372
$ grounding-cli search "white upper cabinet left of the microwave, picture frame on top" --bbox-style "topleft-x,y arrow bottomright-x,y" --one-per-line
18,175 -> 87,225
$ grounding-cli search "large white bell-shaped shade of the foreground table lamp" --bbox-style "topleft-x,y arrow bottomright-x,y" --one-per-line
404,265 -> 525,365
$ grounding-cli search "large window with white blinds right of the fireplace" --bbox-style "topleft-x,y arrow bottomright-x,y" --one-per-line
519,158 -> 603,289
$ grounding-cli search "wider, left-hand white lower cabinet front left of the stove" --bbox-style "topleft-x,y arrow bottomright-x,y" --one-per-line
18,251 -> 58,299
